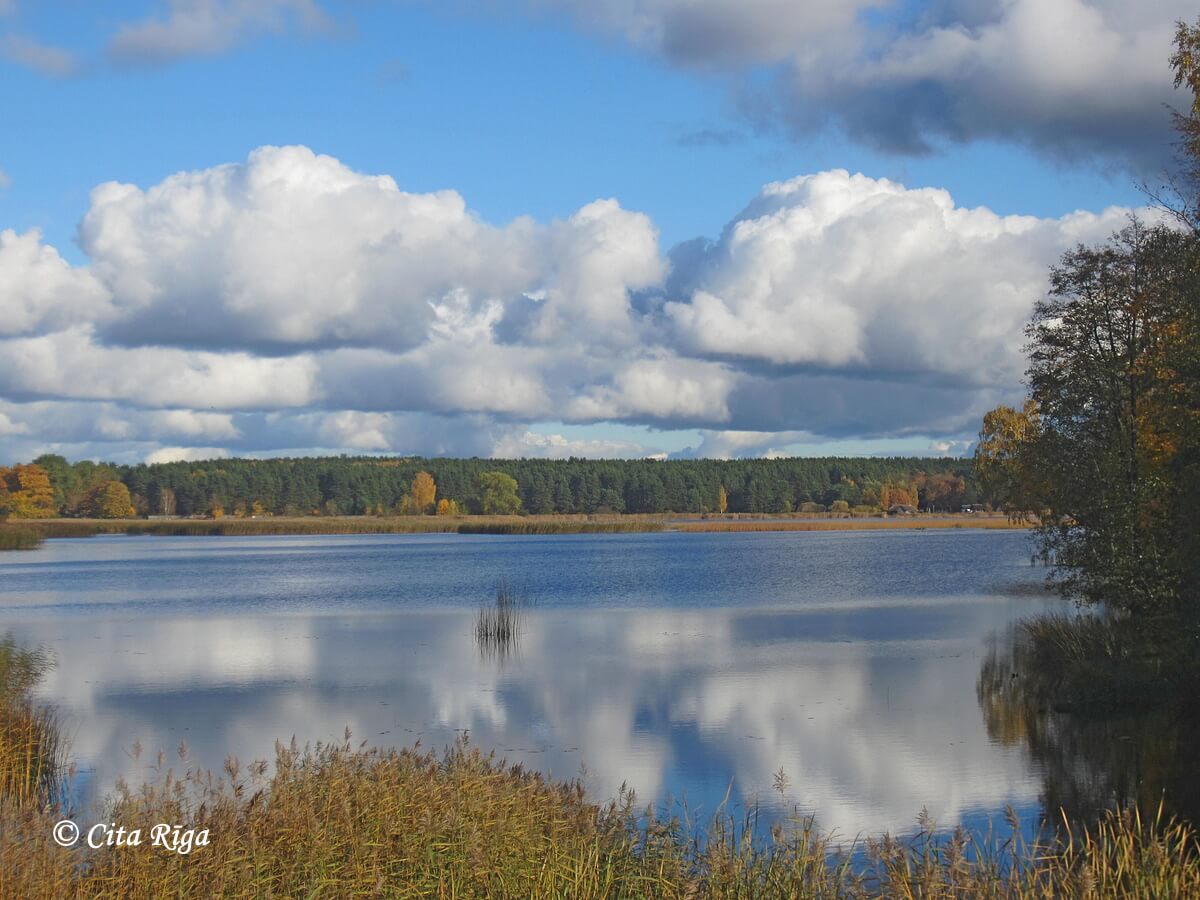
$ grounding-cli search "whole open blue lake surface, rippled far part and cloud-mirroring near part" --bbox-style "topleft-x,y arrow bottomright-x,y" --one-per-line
0,530 -> 1057,836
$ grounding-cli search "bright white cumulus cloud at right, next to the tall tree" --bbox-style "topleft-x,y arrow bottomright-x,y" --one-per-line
665,170 -> 1142,384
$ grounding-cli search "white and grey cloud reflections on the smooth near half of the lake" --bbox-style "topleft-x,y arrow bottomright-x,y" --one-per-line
7,598 -> 1060,835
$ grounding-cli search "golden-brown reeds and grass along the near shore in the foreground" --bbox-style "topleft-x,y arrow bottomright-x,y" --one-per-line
0,638 -> 1200,900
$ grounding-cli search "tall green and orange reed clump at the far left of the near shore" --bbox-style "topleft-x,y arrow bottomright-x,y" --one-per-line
0,637 -> 67,810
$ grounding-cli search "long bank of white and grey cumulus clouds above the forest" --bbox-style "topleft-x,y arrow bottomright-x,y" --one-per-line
0,148 -> 1152,460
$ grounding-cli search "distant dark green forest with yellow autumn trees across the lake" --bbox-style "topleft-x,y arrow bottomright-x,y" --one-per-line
0,454 -> 986,518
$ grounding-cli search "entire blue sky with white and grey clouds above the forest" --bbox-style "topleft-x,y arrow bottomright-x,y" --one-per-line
0,7 -> 1192,461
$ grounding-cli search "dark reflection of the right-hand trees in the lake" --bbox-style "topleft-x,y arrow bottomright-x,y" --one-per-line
977,628 -> 1200,824
